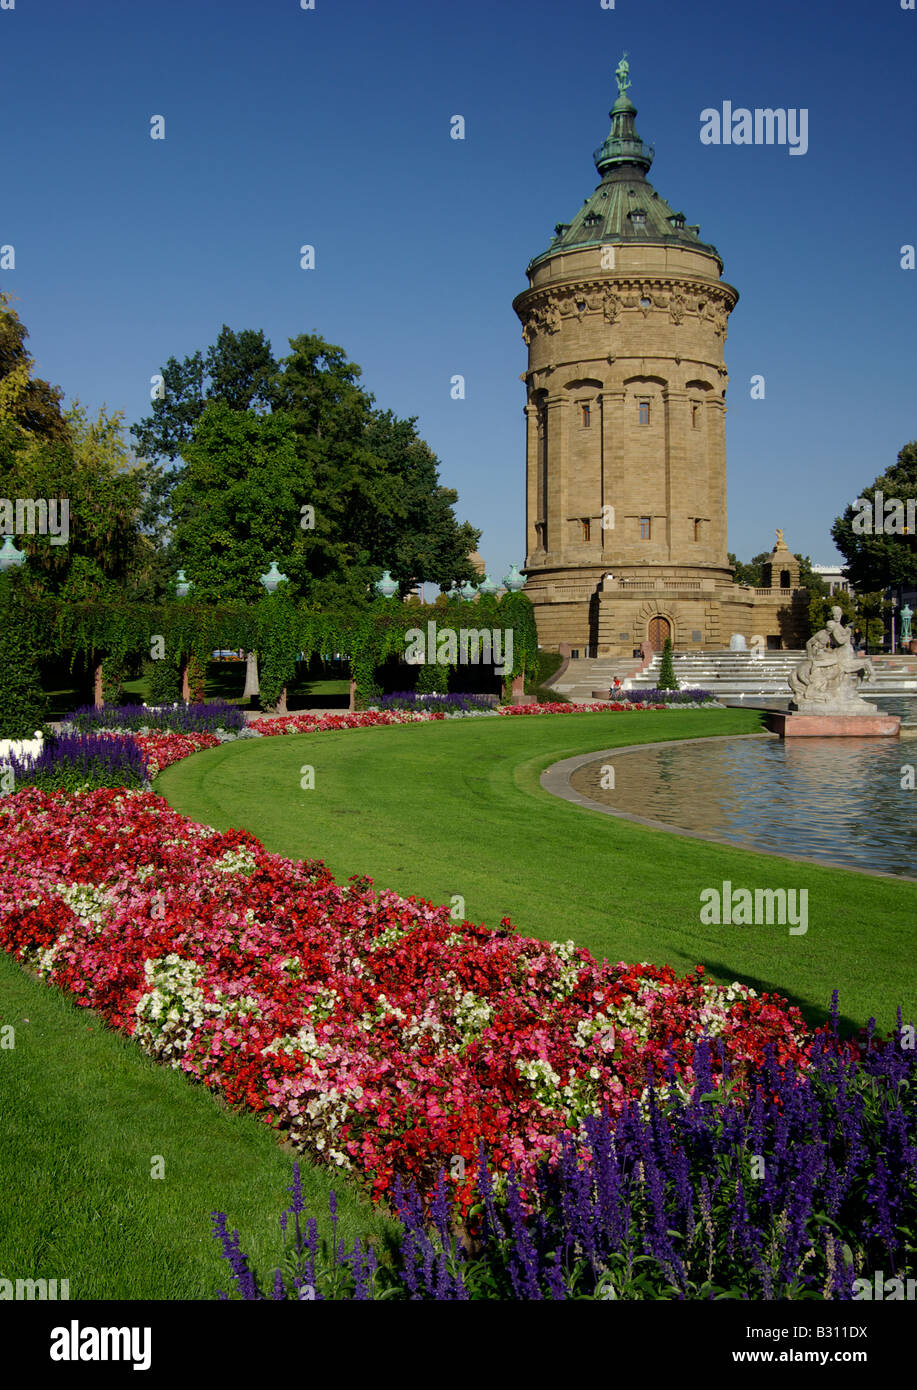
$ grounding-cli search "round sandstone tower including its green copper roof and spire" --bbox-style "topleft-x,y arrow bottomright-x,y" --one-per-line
513,60 -> 796,656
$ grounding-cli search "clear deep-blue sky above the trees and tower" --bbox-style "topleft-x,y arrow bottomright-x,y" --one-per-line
0,0 -> 917,577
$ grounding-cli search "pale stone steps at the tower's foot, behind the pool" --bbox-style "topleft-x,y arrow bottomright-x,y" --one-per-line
553,651 -> 917,703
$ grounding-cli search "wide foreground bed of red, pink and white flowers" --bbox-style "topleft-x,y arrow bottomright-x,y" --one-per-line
0,783 -> 811,1195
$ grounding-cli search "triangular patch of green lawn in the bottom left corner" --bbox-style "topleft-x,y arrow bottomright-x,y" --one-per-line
0,952 -> 393,1298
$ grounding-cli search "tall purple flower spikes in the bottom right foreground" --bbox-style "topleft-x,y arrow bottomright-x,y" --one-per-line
214,995 -> 917,1300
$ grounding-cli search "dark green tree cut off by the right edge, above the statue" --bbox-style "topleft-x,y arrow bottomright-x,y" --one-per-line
831,439 -> 917,594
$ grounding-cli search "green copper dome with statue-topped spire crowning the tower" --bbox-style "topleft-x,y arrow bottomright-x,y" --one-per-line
528,54 -> 722,272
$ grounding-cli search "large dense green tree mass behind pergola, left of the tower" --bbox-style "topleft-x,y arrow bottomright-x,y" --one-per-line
144,327 -> 481,606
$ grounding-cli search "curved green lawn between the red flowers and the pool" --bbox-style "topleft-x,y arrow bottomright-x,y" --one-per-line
157,710 -> 917,1029
